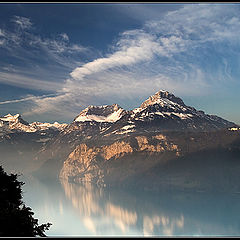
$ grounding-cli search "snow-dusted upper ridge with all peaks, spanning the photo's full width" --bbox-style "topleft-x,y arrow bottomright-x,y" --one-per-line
0,90 -> 237,132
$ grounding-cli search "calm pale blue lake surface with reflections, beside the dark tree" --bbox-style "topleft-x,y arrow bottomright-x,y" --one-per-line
19,176 -> 240,236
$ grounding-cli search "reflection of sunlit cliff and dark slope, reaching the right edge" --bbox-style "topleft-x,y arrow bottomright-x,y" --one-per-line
59,181 -> 240,236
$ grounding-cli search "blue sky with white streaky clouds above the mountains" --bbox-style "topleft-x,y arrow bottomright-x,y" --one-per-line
0,3 -> 240,124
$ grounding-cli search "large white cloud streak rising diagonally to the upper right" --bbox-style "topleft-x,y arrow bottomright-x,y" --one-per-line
68,5 -> 236,90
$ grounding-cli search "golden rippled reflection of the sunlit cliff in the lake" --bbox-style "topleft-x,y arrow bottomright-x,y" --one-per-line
61,181 -> 184,235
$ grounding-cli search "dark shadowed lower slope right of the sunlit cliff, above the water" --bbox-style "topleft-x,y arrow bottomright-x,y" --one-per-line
119,148 -> 240,193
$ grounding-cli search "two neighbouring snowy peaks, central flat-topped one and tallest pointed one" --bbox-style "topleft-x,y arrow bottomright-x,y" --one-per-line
69,90 -> 237,131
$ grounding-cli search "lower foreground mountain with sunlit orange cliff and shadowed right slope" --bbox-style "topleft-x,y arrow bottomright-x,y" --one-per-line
60,128 -> 240,191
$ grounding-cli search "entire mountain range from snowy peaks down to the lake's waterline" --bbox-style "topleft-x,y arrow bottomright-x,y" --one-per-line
0,90 -> 240,193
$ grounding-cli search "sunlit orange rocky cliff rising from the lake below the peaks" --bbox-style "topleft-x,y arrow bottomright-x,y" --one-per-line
60,134 -> 180,185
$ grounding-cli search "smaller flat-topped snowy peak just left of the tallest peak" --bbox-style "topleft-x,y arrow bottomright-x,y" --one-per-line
74,104 -> 125,122
